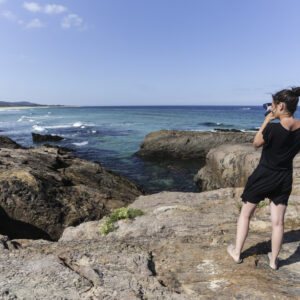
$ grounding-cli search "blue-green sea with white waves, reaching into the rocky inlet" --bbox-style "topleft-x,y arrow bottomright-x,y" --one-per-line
0,105 -> 300,194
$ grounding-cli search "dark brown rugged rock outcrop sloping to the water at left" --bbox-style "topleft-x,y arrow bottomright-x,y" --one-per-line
0,144 -> 145,240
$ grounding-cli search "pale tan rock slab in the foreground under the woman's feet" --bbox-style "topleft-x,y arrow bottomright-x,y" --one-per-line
0,188 -> 300,300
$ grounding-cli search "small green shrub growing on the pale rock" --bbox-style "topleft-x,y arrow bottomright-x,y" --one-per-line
100,207 -> 146,235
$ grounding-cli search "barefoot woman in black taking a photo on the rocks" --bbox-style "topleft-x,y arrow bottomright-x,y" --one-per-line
227,87 -> 300,270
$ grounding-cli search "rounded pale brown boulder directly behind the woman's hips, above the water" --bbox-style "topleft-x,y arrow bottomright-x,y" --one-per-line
194,143 -> 300,195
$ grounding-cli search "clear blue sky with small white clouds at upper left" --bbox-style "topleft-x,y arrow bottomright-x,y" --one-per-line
0,0 -> 300,106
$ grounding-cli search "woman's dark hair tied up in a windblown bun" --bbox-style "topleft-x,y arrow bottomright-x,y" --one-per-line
272,87 -> 300,115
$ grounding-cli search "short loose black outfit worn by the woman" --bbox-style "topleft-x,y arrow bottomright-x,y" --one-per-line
241,122 -> 300,205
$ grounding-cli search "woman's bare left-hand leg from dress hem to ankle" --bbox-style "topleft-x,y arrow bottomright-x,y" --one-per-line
233,201 -> 257,260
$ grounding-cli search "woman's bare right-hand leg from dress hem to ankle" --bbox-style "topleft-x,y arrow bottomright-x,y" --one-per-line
270,201 -> 287,268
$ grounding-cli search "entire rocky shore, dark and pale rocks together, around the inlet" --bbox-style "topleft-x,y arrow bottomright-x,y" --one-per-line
0,130 -> 300,300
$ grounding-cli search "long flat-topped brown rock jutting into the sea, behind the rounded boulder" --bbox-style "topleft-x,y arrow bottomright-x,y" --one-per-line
135,130 -> 256,160
